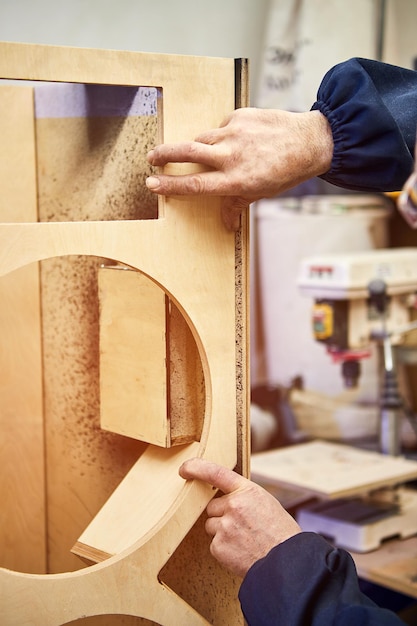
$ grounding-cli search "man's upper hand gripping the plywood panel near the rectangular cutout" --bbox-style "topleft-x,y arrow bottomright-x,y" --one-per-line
146,108 -> 333,229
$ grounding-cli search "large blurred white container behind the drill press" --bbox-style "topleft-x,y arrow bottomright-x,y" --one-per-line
252,194 -> 390,402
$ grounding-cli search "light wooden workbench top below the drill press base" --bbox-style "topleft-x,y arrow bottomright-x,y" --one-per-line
351,537 -> 417,598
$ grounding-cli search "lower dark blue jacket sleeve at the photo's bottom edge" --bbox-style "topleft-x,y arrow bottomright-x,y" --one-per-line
239,532 -> 404,626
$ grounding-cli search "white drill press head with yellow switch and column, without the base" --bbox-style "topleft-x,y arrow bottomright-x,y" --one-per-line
298,248 -> 417,455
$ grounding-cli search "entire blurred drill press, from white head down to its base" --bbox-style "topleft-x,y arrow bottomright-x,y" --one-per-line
292,248 -> 417,552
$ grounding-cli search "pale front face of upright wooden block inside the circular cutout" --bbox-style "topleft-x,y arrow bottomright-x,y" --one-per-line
99,267 -> 171,447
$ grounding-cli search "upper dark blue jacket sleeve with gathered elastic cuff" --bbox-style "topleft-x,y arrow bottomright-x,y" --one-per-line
312,58 -> 417,191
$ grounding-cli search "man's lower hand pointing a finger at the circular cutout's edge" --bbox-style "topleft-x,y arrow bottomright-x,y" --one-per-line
179,458 -> 301,577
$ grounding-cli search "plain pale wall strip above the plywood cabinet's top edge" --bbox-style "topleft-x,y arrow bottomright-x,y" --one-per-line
0,0 -> 269,94
